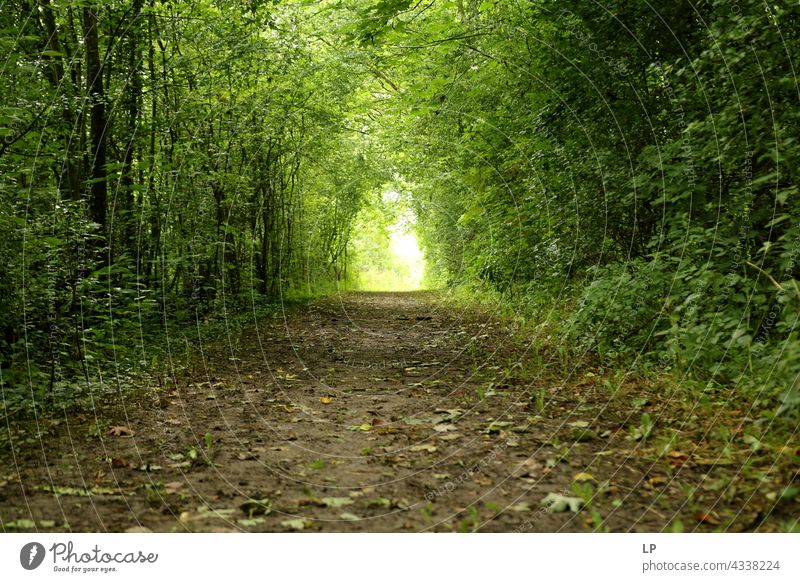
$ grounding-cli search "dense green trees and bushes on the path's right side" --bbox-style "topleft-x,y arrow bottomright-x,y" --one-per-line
350,0 -> 800,420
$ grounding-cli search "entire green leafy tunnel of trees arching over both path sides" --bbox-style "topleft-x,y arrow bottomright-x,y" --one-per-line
0,0 -> 800,432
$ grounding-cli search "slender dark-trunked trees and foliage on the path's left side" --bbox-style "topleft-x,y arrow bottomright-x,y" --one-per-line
0,0 -> 382,424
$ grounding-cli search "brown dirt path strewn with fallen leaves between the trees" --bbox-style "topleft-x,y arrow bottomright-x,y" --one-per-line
0,293 -> 800,532
